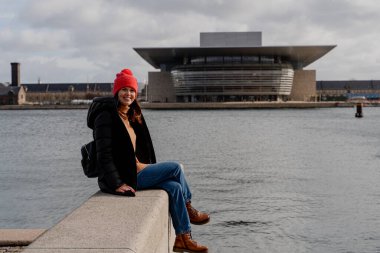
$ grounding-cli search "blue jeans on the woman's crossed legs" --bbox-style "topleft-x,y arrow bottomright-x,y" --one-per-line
137,162 -> 191,235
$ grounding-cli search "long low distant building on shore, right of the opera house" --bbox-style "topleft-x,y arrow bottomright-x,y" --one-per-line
317,80 -> 380,101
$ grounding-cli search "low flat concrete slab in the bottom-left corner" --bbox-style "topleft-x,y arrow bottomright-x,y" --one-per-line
0,229 -> 45,246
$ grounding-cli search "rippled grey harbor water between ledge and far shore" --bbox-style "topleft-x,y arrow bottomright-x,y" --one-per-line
0,107 -> 380,253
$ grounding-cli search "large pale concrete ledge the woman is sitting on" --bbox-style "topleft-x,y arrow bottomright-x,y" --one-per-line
23,190 -> 174,253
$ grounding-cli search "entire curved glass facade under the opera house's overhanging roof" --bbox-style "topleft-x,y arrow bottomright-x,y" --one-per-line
171,56 -> 294,102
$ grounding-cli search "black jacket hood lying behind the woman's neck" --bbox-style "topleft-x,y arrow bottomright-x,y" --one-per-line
87,97 -> 117,129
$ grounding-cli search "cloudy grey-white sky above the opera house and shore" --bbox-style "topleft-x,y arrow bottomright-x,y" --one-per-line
0,0 -> 380,83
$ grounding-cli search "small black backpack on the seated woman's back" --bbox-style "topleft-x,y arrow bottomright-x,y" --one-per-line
80,141 -> 99,178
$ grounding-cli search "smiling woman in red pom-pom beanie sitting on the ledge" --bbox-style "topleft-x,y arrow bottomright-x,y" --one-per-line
87,69 -> 210,252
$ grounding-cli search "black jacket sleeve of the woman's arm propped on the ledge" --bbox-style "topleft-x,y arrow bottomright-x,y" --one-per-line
94,111 -> 123,190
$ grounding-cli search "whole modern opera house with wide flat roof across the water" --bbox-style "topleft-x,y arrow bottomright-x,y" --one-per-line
134,32 -> 335,102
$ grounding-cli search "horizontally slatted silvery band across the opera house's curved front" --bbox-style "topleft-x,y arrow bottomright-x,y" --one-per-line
171,64 -> 294,96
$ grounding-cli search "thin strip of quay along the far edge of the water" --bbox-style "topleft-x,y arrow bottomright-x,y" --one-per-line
0,101 -> 380,110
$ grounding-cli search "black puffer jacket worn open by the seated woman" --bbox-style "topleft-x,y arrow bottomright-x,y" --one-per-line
87,97 -> 156,193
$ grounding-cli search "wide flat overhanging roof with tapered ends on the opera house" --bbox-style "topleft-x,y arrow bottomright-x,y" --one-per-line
134,45 -> 336,69
